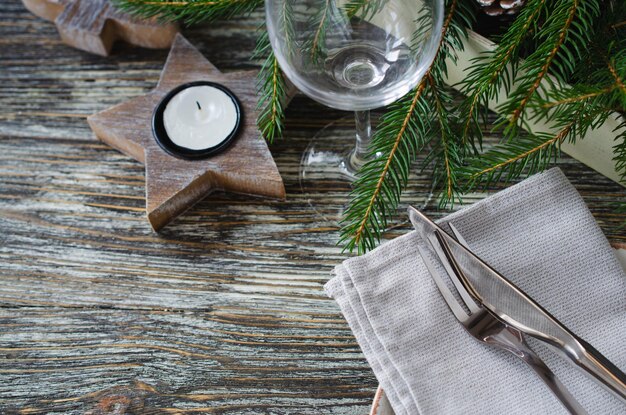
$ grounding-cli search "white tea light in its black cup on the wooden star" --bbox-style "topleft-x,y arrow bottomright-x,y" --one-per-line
153,81 -> 241,159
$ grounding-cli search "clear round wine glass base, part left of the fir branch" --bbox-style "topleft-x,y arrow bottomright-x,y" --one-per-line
300,116 -> 372,226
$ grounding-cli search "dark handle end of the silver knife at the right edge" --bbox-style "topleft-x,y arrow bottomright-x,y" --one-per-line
577,338 -> 626,403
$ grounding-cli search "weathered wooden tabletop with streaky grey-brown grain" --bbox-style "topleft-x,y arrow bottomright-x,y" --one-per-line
0,0 -> 626,414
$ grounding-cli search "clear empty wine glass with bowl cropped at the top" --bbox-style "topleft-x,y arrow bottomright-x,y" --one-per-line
265,0 -> 444,221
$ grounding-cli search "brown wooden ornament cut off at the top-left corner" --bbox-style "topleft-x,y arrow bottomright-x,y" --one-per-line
22,0 -> 178,56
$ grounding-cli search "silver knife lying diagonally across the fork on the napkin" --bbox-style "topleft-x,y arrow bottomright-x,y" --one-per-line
409,207 -> 626,403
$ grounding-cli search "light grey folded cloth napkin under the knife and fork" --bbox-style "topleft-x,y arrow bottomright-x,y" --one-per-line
325,169 -> 626,415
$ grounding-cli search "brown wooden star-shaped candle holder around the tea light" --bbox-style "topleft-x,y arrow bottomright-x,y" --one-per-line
88,35 -> 285,230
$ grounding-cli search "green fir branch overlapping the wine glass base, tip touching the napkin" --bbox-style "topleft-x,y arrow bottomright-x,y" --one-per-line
339,0 -> 472,254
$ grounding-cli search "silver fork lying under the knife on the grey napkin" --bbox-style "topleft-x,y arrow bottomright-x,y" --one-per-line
418,228 -> 587,415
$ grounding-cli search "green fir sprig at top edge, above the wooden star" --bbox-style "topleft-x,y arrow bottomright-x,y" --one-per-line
112,0 -> 263,24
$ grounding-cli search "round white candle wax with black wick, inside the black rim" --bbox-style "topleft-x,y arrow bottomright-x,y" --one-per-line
163,85 -> 238,150
